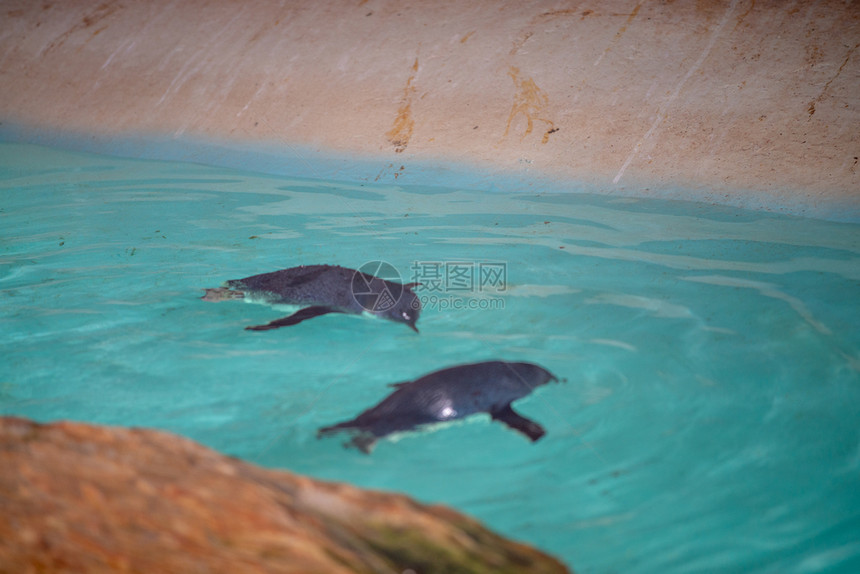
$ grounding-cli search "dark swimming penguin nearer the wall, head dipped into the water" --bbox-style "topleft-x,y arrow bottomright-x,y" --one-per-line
202,265 -> 421,333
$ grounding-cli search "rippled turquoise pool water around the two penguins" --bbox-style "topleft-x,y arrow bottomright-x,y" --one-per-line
0,144 -> 860,573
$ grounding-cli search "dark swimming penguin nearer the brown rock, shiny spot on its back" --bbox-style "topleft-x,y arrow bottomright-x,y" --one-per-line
317,361 -> 558,454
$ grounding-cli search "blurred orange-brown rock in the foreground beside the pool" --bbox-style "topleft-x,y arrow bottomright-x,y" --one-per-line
0,417 -> 568,574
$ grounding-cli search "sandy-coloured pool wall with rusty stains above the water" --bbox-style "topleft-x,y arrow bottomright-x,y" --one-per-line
0,0 -> 860,219
